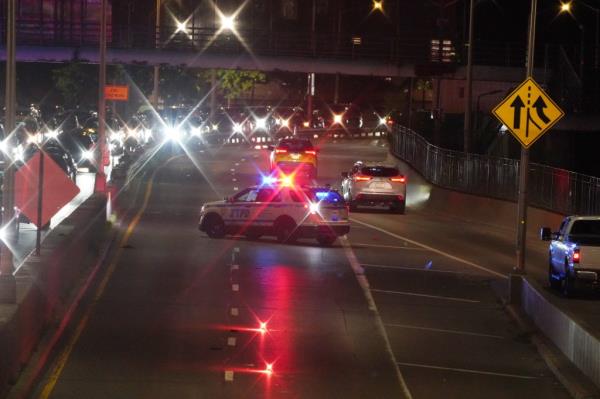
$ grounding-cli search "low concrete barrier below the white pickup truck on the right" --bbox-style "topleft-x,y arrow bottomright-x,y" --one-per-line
521,278 -> 600,387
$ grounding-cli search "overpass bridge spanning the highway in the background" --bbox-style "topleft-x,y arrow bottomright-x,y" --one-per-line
0,20 -> 524,77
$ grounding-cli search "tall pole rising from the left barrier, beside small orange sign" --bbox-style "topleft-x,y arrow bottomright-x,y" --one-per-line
94,0 -> 106,193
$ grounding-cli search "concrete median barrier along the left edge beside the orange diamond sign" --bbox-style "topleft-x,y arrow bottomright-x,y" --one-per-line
0,195 -> 110,397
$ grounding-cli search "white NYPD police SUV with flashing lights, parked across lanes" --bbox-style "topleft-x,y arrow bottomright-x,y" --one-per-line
198,183 -> 350,245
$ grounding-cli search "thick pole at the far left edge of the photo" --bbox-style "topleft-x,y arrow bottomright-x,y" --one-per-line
0,0 -> 18,304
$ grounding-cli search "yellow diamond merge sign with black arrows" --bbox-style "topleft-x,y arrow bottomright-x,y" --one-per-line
492,78 -> 565,148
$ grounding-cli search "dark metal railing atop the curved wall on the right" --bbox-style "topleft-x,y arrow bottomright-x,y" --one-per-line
390,126 -> 600,215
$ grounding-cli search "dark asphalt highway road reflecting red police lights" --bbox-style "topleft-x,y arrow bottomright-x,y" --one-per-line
19,141 -> 569,399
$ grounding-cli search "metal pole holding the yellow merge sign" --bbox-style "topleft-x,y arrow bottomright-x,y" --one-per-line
515,0 -> 537,274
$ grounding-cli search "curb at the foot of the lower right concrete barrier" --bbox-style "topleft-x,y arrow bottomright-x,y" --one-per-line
505,305 -> 600,399
